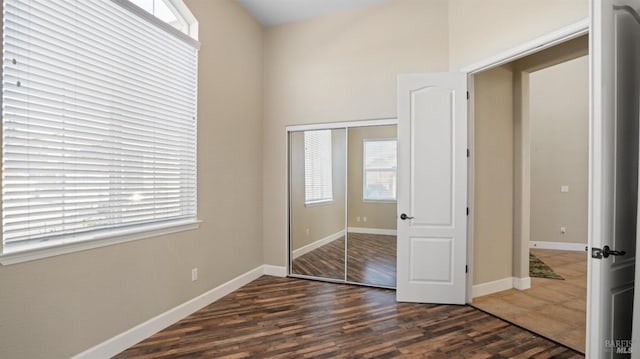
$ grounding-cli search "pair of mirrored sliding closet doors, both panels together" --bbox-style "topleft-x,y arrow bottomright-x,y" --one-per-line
289,124 -> 397,288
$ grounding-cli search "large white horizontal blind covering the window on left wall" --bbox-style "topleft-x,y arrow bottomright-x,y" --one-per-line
2,0 -> 197,253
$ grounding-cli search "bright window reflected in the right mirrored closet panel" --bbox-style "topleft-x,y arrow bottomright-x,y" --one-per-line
362,139 -> 397,201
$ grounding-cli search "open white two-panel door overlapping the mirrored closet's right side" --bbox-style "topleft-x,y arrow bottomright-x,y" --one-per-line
396,73 -> 467,304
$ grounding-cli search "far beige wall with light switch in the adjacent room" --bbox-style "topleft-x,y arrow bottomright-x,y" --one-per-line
529,56 -> 589,244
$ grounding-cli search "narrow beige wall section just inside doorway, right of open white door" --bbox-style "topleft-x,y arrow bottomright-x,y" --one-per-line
472,67 -> 513,284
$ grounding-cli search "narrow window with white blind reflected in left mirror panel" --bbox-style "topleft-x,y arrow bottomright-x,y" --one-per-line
304,130 -> 333,204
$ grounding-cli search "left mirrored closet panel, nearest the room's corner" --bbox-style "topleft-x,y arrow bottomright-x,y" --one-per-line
289,128 -> 347,280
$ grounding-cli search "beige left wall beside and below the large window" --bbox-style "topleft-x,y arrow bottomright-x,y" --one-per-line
0,0 -> 264,359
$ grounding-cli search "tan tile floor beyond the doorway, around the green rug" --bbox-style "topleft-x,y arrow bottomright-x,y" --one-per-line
473,249 -> 587,353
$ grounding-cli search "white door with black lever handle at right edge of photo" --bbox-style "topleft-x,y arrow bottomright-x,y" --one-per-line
587,0 -> 640,358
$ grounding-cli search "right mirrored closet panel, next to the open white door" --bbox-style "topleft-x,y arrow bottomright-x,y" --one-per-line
347,125 -> 397,288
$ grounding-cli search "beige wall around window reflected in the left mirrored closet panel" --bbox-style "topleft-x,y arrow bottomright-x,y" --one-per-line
290,129 -> 347,250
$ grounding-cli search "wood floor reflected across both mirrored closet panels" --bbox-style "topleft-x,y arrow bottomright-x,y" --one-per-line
292,233 -> 396,287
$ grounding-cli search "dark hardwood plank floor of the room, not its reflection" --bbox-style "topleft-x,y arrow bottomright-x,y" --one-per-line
116,276 -> 583,359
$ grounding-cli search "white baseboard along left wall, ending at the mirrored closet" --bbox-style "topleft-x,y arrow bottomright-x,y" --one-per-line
73,265 -> 286,359
